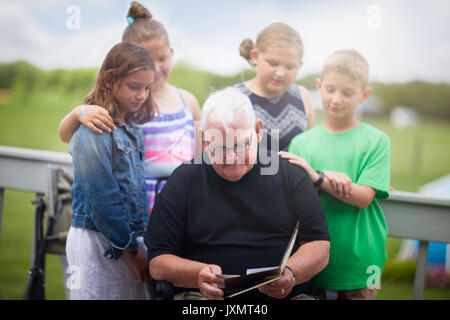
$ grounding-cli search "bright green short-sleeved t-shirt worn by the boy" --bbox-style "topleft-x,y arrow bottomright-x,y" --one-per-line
289,123 -> 390,290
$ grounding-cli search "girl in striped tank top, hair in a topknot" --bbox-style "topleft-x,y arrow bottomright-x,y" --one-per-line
59,1 -> 200,213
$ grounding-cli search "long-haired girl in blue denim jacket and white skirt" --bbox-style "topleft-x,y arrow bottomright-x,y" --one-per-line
66,42 -> 155,299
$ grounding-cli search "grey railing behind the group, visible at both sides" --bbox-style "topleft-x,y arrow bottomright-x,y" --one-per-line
0,146 -> 450,299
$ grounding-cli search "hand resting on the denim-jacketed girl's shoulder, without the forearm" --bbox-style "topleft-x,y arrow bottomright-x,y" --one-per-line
77,105 -> 116,134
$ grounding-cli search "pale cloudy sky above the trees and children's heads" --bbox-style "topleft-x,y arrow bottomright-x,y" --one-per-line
0,0 -> 450,82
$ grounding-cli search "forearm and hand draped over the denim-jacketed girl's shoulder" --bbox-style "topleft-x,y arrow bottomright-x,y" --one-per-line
59,105 -> 116,143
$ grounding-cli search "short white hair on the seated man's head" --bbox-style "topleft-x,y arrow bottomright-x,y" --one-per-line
201,87 -> 256,132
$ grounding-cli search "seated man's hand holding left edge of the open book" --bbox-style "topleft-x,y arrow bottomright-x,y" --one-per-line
197,264 -> 225,300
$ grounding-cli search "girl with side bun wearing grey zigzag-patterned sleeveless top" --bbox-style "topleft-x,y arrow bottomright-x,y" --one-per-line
235,23 -> 315,152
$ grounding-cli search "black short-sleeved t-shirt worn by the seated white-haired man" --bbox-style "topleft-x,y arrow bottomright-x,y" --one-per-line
146,150 -> 329,299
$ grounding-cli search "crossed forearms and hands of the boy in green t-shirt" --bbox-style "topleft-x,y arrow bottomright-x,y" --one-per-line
279,151 -> 376,209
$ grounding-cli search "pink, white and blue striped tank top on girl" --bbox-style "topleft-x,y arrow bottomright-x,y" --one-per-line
140,89 -> 194,214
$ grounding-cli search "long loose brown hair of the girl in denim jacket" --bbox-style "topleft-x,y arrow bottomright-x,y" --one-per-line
84,42 -> 156,124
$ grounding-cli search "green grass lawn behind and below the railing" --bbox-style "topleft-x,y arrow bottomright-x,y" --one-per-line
0,92 -> 450,299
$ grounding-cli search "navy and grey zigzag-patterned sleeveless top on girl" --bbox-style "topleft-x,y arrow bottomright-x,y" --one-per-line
235,82 -> 308,152
